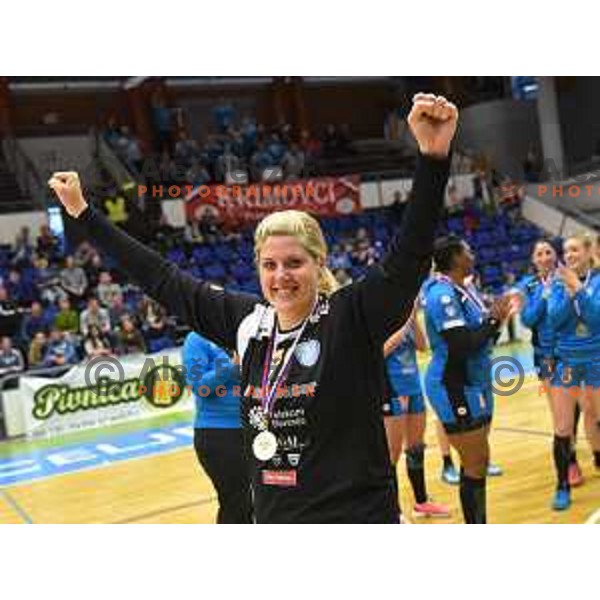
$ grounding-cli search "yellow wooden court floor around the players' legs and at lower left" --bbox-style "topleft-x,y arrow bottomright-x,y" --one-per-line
0,380 -> 600,523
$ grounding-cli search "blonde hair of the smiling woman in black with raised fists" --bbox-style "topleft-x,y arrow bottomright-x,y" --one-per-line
254,210 -> 340,296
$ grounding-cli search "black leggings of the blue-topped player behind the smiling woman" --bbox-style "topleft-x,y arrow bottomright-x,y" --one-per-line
194,429 -> 254,524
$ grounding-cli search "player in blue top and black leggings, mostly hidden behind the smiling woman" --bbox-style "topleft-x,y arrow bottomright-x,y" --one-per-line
183,332 -> 253,524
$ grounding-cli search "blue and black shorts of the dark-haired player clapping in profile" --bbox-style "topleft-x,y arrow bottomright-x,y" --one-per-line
426,383 -> 494,433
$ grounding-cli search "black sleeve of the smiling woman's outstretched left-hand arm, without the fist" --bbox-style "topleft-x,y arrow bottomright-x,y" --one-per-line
66,207 -> 260,350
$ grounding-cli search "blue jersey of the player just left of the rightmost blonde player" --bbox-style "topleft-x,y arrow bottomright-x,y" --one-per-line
517,275 -> 556,358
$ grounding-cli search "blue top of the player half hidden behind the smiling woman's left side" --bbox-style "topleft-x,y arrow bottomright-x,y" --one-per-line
183,332 -> 241,429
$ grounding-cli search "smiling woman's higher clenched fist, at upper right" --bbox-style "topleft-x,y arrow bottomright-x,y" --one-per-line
408,94 -> 458,158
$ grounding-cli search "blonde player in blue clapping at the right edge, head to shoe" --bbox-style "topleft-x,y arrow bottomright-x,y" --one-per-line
547,235 -> 600,510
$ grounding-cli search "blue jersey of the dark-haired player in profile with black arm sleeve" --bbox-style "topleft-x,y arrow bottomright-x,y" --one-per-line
423,276 -> 492,398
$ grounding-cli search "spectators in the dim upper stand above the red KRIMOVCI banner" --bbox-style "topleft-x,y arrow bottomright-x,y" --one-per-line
104,99 -> 352,191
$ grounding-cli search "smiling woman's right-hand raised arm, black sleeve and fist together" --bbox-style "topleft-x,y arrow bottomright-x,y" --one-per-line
357,94 -> 458,347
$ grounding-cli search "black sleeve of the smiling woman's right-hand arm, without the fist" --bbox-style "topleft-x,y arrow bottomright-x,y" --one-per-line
355,155 -> 450,347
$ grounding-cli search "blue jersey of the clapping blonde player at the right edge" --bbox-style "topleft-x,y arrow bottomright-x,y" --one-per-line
548,270 -> 600,364
